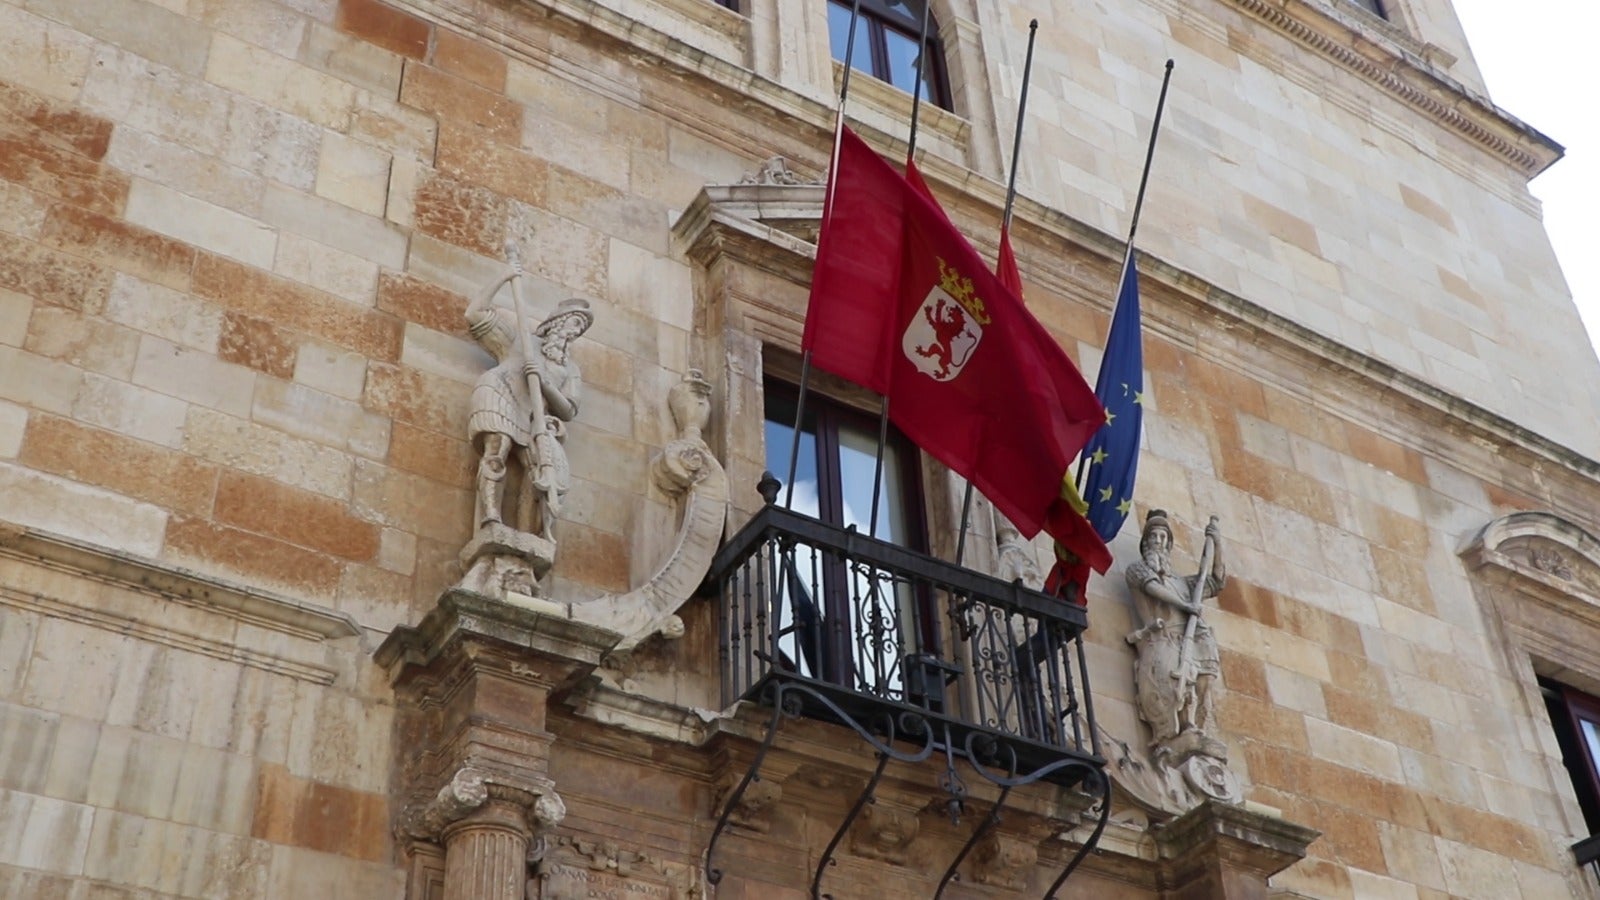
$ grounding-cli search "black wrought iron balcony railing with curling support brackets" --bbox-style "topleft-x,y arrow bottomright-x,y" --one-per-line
707,486 -> 1110,894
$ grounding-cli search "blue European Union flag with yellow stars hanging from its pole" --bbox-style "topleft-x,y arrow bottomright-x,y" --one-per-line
1080,253 -> 1144,543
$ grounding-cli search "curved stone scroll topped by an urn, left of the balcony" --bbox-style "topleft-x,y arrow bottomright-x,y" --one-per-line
571,370 -> 728,658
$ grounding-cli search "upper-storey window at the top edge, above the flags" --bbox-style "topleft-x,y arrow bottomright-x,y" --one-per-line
827,0 -> 950,109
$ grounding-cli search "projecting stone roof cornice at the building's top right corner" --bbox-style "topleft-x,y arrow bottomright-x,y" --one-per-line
1224,0 -> 1565,178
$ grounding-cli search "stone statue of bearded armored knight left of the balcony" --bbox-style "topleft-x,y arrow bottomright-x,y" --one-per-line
461,247 -> 594,596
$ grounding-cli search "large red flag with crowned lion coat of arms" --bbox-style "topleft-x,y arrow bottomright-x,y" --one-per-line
802,128 -> 1106,547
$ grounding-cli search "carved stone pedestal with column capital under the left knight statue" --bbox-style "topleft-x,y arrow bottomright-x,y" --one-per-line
378,591 -> 621,900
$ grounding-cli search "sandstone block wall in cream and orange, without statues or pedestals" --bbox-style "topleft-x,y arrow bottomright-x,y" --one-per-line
0,0 -> 1600,900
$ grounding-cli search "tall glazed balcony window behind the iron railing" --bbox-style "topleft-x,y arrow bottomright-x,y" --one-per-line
765,381 -> 938,688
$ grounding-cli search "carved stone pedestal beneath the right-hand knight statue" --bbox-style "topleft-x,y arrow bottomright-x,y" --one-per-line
1157,801 -> 1322,900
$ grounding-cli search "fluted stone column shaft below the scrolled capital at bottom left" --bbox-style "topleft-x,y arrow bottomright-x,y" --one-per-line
443,799 -> 531,900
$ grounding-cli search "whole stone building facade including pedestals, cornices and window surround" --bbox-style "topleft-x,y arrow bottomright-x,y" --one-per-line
0,0 -> 1600,900
